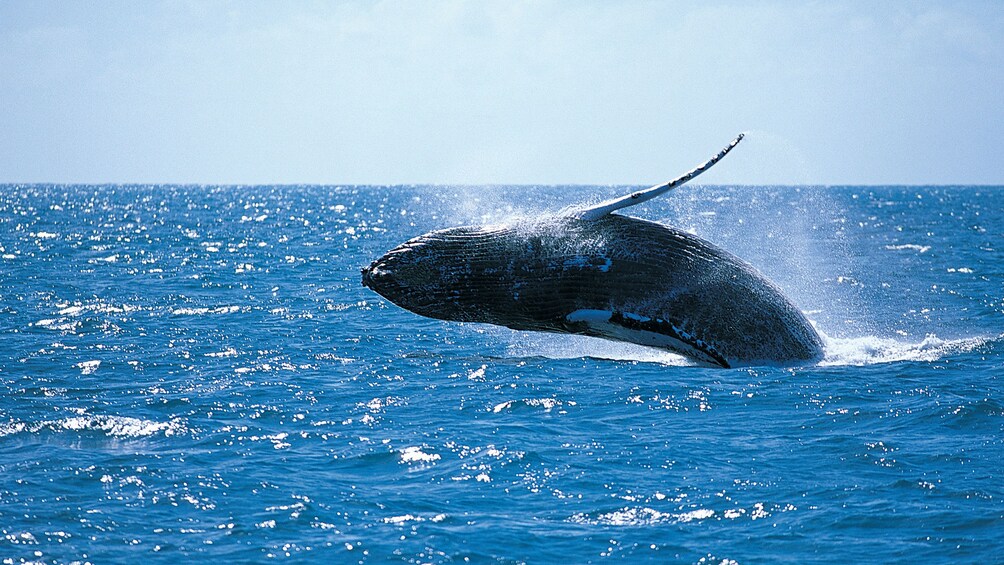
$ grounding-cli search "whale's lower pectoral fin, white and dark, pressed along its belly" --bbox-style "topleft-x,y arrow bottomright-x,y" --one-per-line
565,310 -> 730,368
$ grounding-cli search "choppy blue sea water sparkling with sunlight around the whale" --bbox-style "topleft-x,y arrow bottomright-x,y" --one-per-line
0,186 -> 1004,563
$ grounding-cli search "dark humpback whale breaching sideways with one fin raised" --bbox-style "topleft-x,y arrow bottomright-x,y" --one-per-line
361,133 -> 823,368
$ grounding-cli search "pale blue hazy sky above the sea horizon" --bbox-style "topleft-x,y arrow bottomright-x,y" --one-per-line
0,0 -> 1004,185
